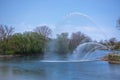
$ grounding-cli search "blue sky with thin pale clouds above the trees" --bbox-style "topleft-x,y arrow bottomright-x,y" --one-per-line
0,0 -> 120,40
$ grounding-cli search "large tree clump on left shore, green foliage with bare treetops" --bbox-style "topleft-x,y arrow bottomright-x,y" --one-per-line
0,25 -> 52,55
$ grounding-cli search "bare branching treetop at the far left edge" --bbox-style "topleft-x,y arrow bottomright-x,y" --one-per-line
0,25 -> 14,40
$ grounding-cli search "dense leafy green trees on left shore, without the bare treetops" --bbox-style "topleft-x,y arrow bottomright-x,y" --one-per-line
10,32 -> 46,55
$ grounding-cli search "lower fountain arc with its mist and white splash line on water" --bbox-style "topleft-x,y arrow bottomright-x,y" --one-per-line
42,42 -> 107,62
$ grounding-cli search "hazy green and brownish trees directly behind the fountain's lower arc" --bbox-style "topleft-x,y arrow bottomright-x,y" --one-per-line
56,32 -> 92,54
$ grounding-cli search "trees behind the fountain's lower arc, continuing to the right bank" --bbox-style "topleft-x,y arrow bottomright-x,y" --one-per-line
56,32 -> 120,54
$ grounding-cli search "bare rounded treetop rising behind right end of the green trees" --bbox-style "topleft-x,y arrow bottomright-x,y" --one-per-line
34,26 -> 52,38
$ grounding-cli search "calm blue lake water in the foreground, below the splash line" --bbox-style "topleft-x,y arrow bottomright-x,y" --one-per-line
0,58 -> 120,80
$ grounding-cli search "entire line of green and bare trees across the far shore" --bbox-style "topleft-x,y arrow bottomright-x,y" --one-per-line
0,19 -> 120,55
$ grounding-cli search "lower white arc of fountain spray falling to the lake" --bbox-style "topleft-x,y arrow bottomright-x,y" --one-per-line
70,42 -> 107,61
